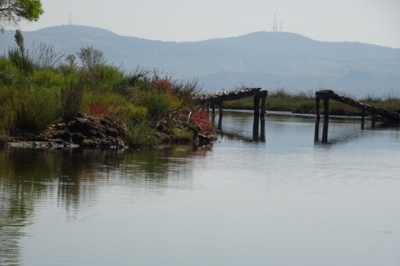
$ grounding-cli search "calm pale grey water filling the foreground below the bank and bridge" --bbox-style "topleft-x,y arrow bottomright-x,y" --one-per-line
0,113 -> 400,266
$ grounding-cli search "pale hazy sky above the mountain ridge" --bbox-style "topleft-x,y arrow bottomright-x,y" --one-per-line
14,0 -> 400,48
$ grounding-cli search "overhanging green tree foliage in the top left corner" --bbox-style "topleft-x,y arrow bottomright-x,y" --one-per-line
0,0 -> 44,31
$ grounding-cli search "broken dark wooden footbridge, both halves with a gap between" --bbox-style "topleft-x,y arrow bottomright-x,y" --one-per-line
196,88 -> 400,143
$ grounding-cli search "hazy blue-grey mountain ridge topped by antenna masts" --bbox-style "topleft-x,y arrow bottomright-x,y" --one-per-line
0,26 -> 400,97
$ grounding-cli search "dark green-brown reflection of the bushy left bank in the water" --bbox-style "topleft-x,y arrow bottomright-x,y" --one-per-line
0,146 -> 206,265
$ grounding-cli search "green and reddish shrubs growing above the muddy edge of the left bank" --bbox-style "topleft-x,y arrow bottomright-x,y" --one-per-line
0,31 -> 211,149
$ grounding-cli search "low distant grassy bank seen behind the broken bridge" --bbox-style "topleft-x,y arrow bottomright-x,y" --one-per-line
224,89 -> 400,115
